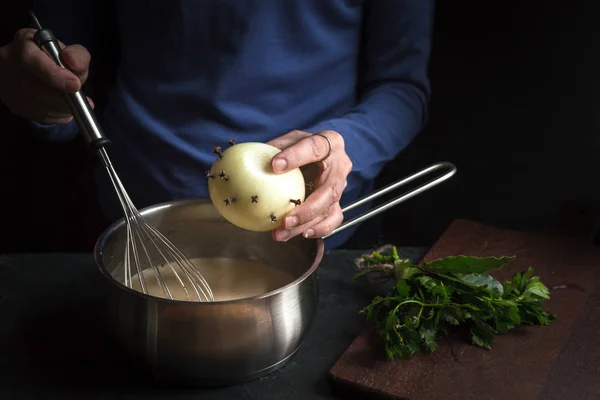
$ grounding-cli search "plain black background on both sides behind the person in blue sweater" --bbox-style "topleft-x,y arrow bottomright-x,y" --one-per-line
0,0 -> 600,252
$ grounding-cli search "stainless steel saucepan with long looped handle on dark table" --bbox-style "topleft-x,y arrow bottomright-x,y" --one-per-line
94,163 -> 456,386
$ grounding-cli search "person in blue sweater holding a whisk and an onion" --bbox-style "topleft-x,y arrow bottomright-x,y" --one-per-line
0,0 -> 434,248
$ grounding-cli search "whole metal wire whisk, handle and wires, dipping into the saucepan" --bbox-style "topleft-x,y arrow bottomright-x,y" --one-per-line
29,11 -> 214,301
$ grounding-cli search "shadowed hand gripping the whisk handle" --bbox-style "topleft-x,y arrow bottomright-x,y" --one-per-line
0,29 -> 94,124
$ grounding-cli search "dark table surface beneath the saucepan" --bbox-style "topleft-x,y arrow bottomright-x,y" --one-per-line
0,248 -> 427,400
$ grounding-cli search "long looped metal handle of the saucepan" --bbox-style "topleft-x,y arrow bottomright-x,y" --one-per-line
321,162 -> 456,239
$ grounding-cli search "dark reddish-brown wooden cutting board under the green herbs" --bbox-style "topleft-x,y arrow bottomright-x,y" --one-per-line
329,220 -> 600,400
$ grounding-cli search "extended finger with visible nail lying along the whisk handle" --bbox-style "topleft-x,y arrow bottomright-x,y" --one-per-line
16,30 -> 81,93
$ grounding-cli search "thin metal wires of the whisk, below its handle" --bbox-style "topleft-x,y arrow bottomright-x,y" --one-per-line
98,148 -> 214,301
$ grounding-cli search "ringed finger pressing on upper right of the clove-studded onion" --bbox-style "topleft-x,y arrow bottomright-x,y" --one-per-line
271,133 -> 331,173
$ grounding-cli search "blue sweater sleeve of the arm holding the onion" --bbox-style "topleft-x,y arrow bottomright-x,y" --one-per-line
305,0 -> 434,190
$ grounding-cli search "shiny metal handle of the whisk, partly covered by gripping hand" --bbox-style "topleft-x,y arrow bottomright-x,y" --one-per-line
29,11 -> 110,150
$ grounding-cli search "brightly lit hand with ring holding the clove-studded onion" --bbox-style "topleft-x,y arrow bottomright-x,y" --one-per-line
268,130 -> 352,241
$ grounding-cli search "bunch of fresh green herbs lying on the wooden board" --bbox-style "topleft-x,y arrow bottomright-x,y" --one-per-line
356,246 -> 556,360
